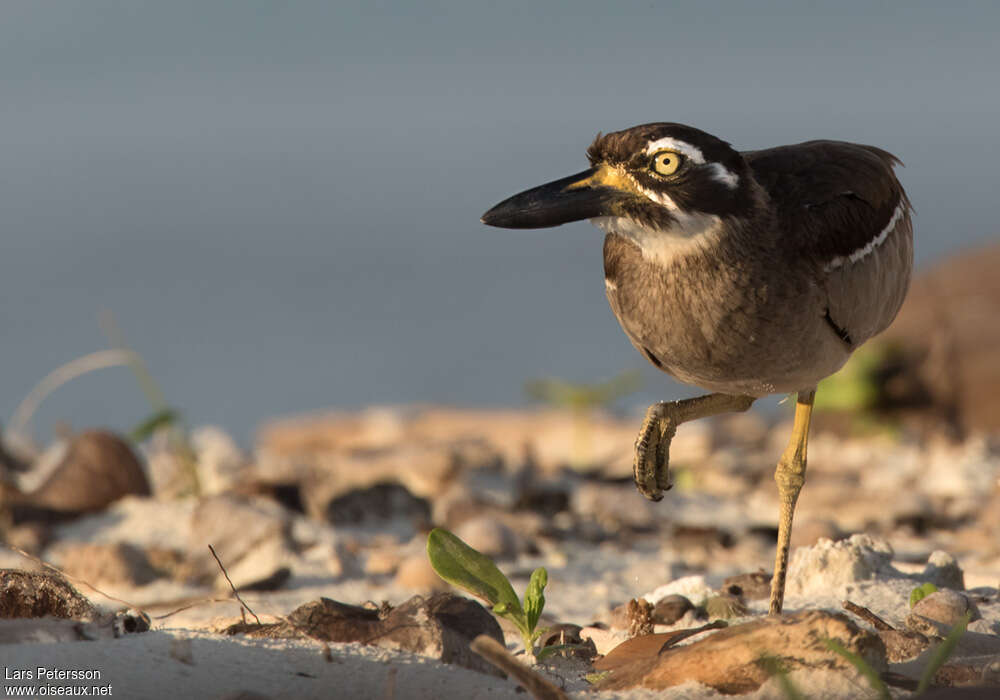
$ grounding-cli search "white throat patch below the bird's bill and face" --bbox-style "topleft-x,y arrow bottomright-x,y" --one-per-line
590,211 -> 722,267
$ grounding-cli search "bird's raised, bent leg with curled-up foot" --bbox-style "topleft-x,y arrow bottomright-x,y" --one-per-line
632,394 -> 754,501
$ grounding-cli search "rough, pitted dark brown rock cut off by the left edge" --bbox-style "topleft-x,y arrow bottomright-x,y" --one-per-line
0,569 -> 97,620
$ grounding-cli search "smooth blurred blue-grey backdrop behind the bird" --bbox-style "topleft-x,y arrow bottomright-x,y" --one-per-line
0,0 -> 1000,440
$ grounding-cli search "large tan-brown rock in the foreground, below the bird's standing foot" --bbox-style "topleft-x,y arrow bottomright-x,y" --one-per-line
596,610 -> 887,694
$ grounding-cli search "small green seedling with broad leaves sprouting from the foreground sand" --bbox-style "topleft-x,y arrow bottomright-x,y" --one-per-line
427,528 -> 549,659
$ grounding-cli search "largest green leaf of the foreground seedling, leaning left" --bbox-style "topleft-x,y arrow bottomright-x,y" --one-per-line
427,528 -> 525,626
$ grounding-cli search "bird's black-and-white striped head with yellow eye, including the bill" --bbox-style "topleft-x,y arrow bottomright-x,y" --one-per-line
482,122 -> 752,235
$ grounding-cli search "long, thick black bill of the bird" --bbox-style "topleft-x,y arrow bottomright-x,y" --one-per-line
482,168 -> 621,228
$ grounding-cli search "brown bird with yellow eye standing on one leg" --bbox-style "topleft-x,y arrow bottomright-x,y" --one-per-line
481,122 -> 913,615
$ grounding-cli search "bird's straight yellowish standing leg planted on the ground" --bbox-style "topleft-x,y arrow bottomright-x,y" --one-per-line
770,389 -> 816,615
